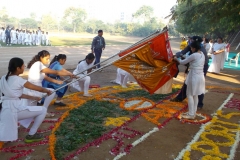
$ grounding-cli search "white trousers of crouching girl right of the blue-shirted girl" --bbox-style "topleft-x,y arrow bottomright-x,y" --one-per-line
71,74 -> 91,94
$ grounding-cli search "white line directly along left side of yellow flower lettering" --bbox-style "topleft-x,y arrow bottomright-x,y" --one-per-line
175,93 -> 235,160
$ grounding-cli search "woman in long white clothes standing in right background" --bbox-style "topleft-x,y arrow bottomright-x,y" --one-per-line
208,37 -> 226,73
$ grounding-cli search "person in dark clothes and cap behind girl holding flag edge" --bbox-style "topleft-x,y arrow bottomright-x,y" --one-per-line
171,36 -> 209,109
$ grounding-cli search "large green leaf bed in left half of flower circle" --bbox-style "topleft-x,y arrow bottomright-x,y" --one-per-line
55,100 -> 138,159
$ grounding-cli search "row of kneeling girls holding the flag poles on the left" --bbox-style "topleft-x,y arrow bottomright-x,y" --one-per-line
0,28 -> 129,143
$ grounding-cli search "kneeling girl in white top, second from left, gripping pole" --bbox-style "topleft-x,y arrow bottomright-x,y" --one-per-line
24,50 -> 73,117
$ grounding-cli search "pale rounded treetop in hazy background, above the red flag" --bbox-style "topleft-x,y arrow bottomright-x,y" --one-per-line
133,5 -> 153,22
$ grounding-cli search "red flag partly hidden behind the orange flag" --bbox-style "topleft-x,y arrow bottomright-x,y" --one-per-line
119,30 -> 173,62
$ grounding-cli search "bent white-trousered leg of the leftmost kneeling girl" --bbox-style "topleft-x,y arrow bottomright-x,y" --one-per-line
17,106 -> 47,135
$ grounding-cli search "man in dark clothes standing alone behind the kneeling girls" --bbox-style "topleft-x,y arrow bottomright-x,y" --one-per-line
91,30 -> 105,68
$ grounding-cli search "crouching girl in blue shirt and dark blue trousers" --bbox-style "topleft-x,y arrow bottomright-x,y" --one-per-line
42,54 -> 70,106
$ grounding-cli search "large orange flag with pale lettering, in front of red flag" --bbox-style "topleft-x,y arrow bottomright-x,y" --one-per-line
113,44 -> 177,94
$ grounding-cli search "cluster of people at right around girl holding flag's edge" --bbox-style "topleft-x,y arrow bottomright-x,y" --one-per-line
171,36 -> 230,119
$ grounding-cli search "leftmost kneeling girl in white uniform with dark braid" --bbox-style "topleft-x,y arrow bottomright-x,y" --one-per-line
0,58 -> 51,143
